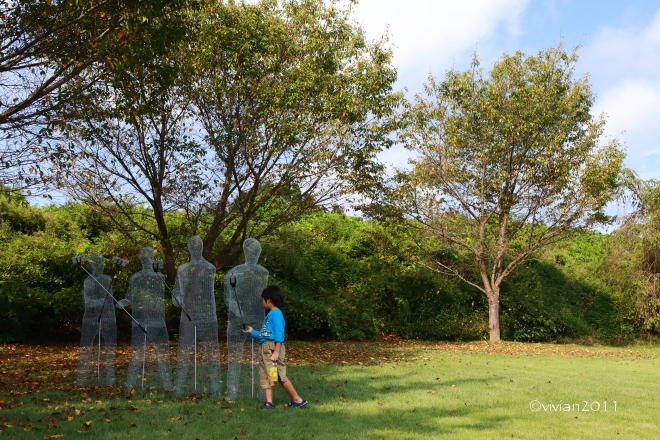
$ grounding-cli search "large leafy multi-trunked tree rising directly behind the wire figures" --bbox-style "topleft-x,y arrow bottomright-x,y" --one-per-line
52,0 -> 399,276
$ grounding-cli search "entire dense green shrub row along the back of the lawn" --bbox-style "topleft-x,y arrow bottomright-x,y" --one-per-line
0,195 -> 634,341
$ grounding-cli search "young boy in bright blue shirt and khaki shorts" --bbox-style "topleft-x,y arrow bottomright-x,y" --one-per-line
243,286 -> 307,409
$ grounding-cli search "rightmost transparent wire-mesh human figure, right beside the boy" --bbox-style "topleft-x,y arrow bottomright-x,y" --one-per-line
225,238 -> 268,400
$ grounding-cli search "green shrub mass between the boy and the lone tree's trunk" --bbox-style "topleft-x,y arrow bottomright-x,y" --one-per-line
263,213 -> 484,340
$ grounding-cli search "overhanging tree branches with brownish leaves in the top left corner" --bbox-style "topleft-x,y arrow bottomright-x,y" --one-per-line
0,0 -> 182,192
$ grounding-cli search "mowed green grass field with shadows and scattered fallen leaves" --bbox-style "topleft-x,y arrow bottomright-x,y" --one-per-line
0,341 -> 660,440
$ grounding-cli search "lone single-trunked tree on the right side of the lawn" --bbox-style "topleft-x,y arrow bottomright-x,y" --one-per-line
367,45 -> 624,341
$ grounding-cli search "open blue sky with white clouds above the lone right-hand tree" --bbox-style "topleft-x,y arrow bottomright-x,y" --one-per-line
346,0 -> 660,179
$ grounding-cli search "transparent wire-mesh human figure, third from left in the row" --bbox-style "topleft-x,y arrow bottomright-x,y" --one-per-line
172,236 -> 222,396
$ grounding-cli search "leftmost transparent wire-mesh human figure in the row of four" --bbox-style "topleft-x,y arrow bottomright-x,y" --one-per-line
76,255 -> 117,386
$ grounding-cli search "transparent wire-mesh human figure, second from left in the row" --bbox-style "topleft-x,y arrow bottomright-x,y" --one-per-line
117,247 -> 172,392
